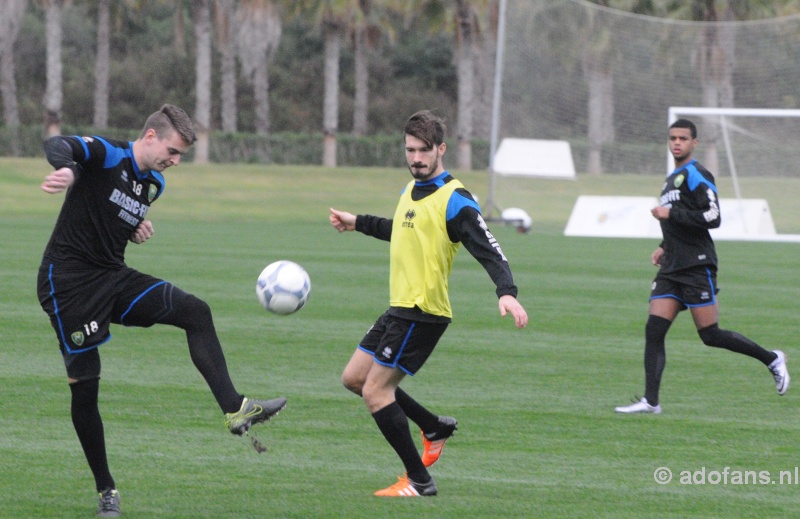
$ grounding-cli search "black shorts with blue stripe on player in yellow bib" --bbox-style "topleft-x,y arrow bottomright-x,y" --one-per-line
358,312 -> 449,376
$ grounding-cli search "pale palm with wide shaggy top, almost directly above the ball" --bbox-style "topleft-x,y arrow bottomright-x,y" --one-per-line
237,0 -> 281,135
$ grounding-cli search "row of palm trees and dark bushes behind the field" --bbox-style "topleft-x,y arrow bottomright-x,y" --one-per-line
0,0 -> 798,169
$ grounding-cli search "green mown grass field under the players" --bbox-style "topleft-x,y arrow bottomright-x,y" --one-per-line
0,159 -> 800,519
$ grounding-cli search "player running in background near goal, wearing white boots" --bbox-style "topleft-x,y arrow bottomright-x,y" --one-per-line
615,119 -> 790,414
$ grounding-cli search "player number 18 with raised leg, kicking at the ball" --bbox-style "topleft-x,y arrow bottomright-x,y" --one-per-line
38,105 -> 286,517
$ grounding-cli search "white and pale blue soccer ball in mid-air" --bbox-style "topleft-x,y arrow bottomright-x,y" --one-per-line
256,260 -> 311,315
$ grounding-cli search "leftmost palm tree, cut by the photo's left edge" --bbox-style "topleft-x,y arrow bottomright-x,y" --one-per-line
0,0 -> 26,156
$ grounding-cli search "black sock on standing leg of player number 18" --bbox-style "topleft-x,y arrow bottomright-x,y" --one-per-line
69,378 -> 116,492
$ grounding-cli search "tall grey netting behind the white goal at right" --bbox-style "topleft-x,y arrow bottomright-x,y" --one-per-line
491,0 -> 800,233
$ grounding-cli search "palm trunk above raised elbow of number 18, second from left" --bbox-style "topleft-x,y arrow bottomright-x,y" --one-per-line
43,0 -> 64,137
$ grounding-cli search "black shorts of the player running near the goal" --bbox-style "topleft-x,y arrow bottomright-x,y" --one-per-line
650,266 -> 719,309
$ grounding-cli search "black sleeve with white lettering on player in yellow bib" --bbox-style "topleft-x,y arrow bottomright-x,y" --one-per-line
447,206 -> 517,297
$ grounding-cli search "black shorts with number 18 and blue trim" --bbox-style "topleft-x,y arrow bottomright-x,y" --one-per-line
38,261 -> 171,355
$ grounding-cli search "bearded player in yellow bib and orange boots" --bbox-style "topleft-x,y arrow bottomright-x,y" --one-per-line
329,111 -> 528,497
